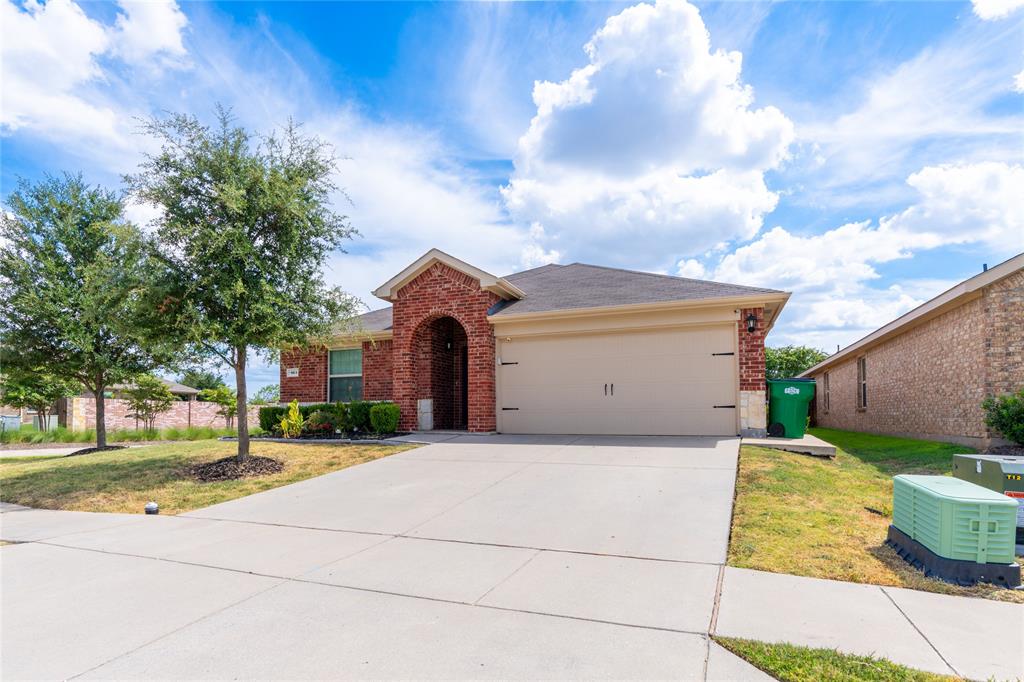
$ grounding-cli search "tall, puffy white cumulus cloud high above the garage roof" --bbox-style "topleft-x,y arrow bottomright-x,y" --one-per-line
503,0 -> 794,264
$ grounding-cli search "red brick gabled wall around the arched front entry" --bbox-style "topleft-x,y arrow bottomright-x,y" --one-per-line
392,263 -> 499,431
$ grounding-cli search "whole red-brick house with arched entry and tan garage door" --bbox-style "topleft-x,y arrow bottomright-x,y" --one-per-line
281,249 -> 790,435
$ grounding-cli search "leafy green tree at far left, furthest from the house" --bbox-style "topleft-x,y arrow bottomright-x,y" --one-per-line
0,174 -> 169,447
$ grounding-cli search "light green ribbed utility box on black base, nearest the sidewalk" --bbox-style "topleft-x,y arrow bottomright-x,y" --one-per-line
888,475 -> 1021,587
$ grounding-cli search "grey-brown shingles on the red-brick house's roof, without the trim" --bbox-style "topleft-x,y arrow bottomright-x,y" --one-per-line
359,263 -> 784,323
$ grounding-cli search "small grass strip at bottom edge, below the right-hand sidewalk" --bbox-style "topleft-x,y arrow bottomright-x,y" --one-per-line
715,637 -> 959,682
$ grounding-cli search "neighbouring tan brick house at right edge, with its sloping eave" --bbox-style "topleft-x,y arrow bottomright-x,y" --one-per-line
801,254 -> 1024,447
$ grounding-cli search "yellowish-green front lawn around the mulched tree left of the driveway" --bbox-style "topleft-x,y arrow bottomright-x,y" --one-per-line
0,440 -> 410,514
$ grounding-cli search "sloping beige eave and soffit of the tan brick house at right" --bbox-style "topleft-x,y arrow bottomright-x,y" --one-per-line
800,253 -> 1024,377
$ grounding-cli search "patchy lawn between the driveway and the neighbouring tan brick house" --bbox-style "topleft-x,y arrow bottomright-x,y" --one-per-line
729,429 -> 1024,603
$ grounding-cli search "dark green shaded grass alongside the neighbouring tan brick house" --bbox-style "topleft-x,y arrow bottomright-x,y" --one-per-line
811,428 -> 974,476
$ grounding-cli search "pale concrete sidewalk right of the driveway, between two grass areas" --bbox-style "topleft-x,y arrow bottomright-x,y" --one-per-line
715,567 -> 1024,680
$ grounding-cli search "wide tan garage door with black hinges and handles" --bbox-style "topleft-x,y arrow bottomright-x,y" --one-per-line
498,325 -> 736,435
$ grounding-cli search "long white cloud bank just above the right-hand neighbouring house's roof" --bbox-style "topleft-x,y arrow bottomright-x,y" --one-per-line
708,163 -> 1024,341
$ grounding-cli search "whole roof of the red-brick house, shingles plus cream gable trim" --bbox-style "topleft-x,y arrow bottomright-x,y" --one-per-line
352,256 -> 790,337
